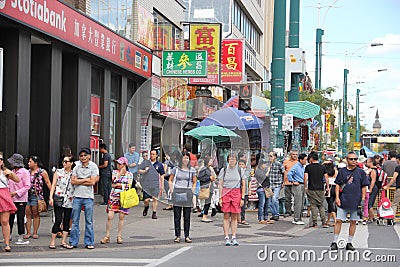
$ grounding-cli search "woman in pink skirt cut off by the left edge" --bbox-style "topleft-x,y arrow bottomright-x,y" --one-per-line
0,153 -> 19,252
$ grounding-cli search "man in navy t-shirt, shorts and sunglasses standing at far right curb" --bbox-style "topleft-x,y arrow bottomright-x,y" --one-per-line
331,152 -> 369,250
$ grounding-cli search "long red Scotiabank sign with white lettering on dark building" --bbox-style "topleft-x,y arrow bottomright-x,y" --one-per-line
0,0 -> 151,77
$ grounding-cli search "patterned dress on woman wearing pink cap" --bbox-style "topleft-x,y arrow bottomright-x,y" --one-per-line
107,170 -> 133,214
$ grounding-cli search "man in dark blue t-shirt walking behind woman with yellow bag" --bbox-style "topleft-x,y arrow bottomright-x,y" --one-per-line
138,149 -> 165,219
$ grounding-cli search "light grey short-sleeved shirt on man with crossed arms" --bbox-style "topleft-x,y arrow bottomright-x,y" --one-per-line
72,161 -> 99,199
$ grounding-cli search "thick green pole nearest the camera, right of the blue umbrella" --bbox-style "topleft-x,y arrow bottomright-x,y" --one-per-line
271,0 -> 286,149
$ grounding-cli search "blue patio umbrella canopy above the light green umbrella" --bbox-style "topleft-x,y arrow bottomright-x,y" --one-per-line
199,107 -> 264,130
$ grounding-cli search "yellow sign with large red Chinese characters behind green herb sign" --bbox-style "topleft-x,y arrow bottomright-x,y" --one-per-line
189,24 -> 221,84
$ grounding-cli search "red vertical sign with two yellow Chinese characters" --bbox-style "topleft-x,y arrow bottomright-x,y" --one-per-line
221,39 -> 244,84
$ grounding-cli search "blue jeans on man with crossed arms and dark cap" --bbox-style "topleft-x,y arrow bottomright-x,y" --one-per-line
69,197 -> 94,247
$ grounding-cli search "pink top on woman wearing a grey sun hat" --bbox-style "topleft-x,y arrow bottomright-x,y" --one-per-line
8,168 -> 31,202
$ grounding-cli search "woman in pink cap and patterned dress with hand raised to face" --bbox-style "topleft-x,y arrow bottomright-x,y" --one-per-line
100,157 -> 134,244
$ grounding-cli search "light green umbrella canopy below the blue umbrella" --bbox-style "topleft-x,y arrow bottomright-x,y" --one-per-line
185,125 -> 240,143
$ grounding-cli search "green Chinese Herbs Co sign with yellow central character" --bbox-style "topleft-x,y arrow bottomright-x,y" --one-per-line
162,50 -> 207,77
